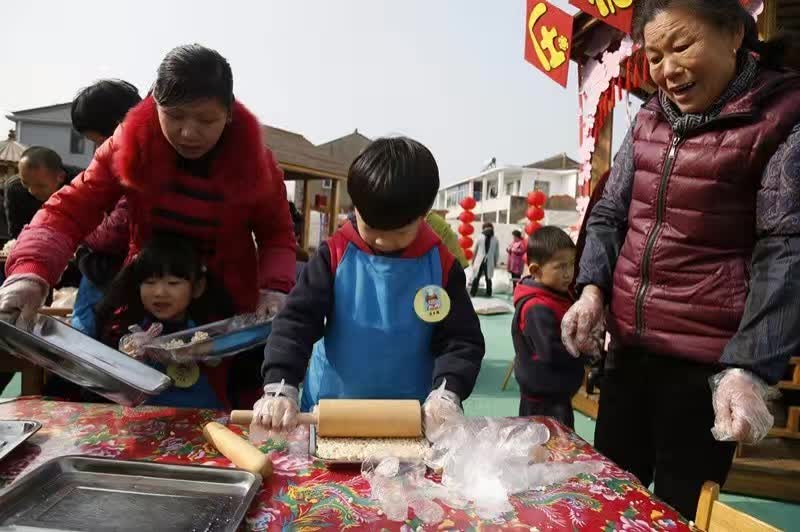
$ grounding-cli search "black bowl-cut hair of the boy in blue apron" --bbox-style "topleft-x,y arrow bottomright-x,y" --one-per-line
347,137 -> 439,231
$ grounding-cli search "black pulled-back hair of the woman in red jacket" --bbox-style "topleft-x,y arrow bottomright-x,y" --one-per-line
153,44 -> 233,109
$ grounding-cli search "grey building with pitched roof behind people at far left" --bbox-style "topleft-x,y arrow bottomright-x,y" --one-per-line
6,103 -> 95,168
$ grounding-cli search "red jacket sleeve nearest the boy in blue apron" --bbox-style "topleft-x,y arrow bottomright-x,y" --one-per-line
252,149 -> 297,293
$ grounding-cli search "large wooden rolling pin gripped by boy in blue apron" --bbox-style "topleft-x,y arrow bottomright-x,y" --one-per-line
231,399 -> 422,438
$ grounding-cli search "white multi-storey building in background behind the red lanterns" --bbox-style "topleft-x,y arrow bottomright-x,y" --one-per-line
434,153 -> 579,226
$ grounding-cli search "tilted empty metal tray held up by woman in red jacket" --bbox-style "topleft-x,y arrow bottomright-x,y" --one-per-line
0,315 -> 172,406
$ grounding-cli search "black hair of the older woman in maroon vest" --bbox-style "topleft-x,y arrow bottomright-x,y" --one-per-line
633,0 -> 798,69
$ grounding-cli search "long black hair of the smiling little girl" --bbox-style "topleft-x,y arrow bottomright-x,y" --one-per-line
95,236 -> 234,347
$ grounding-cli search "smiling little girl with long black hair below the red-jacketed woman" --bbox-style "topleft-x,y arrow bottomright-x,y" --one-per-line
97,237 -> 233,409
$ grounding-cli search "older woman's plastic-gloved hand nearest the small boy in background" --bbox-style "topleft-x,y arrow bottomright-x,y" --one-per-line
561,285 -> 605,358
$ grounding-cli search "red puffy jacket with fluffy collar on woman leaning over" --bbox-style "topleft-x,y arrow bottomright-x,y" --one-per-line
6,97 -> 295,312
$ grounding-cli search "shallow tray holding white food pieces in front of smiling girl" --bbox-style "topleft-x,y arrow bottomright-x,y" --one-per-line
145,314 -> 272,364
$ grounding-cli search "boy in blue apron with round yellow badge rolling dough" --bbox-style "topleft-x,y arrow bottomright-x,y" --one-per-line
254,138 -> 485,433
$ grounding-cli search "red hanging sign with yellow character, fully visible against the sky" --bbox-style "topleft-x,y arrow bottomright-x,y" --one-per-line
525,0 -> 572,87
